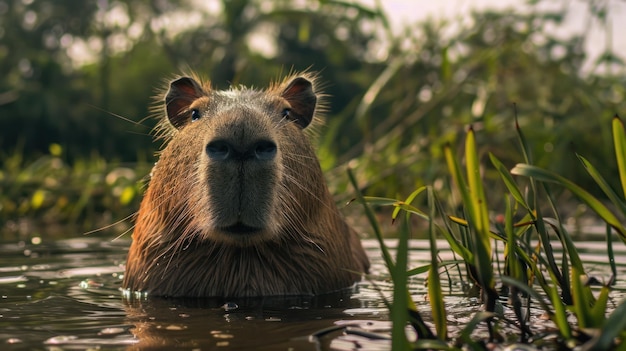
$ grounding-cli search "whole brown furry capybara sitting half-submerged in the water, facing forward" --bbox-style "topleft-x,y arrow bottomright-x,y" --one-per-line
123,74 -> 369,297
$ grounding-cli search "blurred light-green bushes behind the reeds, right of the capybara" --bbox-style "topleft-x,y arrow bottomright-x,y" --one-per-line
326,6 -> 626,201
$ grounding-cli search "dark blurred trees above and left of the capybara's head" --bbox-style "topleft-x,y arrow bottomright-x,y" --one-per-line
0,0 -> 378,162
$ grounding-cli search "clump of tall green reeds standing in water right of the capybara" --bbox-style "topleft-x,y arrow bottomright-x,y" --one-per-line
349,116 -> 626,350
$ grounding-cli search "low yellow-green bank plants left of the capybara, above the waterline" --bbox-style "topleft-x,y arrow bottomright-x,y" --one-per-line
0,144 -> 149,240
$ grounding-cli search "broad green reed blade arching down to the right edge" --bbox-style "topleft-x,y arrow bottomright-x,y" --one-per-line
511,164 -> 626,243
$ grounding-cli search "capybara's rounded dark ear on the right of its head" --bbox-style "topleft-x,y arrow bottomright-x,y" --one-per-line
281,77 -> 317,128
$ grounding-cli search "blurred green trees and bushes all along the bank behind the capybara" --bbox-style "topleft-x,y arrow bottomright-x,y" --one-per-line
0,0 -> 626,236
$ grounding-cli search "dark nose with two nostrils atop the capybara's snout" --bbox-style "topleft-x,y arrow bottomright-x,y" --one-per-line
206,140 -> 276,161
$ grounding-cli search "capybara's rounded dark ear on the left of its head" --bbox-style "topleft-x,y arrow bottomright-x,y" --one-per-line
165,77 -> 206,129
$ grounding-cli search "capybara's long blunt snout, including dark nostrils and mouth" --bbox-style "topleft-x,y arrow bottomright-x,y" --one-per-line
197,109 -> 285,245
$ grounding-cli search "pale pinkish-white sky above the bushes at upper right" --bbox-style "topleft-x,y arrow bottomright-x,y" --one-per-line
358,0 -> 626,73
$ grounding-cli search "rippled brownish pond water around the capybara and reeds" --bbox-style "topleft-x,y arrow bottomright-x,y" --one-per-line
0,238 -> 626,350
